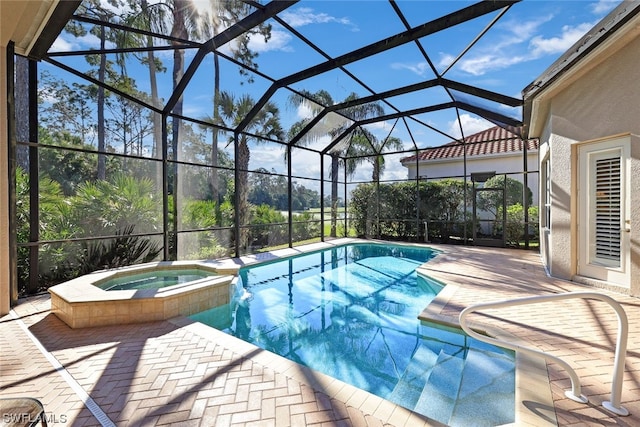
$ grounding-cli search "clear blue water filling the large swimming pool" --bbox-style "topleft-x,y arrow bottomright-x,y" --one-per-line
191,244 -> 515,426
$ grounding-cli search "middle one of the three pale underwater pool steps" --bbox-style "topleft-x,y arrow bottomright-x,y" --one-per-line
414,344 -> 464,424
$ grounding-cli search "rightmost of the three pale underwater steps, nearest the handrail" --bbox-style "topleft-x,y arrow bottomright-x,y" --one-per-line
447,348 -> 515,426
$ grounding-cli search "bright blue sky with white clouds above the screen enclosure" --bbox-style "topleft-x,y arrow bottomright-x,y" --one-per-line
45,0 -> 620,187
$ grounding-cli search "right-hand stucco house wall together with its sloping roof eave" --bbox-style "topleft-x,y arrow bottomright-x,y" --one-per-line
525,4 -> 640,295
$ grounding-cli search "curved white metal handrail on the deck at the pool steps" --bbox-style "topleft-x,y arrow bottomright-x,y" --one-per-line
459,292 -> 629,416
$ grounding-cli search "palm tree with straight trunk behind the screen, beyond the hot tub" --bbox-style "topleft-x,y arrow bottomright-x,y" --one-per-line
216,91 -> 284,250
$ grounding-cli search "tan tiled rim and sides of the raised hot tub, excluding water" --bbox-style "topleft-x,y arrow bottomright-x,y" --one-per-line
49,261 -> 237,328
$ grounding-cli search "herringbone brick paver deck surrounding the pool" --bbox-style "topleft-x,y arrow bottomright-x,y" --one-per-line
0,240 -> 640,427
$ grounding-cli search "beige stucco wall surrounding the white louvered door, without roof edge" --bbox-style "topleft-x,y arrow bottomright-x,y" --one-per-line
538,33 -> 640,295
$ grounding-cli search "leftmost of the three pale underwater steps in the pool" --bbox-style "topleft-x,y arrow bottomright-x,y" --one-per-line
387,344 -> 438,408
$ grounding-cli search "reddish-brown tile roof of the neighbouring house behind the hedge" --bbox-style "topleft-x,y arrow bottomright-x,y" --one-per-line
400,126 -> 538,164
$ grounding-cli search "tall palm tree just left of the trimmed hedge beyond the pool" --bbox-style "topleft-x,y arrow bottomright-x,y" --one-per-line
289,90 -> 384,237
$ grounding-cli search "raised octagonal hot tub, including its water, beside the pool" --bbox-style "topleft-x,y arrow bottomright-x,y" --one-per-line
49,261 -> 237,328
